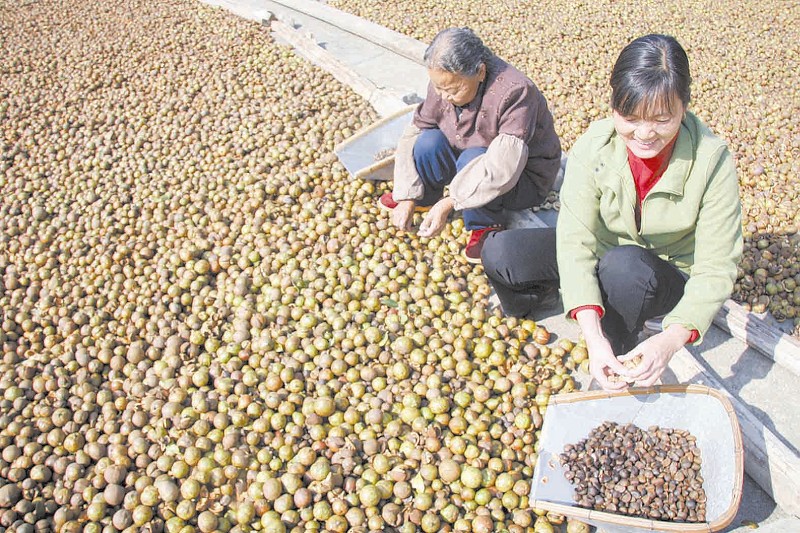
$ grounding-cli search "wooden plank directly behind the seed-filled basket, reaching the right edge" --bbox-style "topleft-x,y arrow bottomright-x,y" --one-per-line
669,348 -> 800,516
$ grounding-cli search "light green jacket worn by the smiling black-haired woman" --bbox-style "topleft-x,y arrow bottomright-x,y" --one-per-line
556,112 -> 742,343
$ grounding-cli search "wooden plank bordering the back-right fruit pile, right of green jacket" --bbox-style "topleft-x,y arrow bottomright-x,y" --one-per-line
714,300 -> 800,376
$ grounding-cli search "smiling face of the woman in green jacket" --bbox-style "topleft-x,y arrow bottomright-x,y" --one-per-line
613,96 -> 686,159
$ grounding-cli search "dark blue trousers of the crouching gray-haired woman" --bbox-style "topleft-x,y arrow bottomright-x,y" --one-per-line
413,129 -> 544,230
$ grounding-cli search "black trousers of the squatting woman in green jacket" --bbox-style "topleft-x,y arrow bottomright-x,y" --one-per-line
482,232 -> 686,355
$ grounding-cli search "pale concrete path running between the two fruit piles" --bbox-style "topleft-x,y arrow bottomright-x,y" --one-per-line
206,0 -> 800,533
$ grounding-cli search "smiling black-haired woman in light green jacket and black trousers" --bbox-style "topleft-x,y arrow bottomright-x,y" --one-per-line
483,35 -> 742,389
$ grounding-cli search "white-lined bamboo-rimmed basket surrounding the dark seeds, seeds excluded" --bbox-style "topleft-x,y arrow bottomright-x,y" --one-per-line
530,385 -> 744,533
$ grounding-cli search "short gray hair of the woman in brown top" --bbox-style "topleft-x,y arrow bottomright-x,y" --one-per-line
423,28 -> 492,76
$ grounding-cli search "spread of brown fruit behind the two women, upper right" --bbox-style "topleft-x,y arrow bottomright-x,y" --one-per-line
329,0 -> 800,337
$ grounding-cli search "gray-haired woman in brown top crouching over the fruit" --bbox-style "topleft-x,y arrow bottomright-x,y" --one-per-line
380,28 -> 561,262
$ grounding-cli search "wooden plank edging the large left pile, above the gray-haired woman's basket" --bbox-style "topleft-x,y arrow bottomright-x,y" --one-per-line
265,17 -> 408,116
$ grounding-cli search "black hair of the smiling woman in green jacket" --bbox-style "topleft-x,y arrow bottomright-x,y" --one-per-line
611,33 -> 692,116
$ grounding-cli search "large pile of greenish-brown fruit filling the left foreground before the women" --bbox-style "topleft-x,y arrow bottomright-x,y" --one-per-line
0,0 -> 586,533
